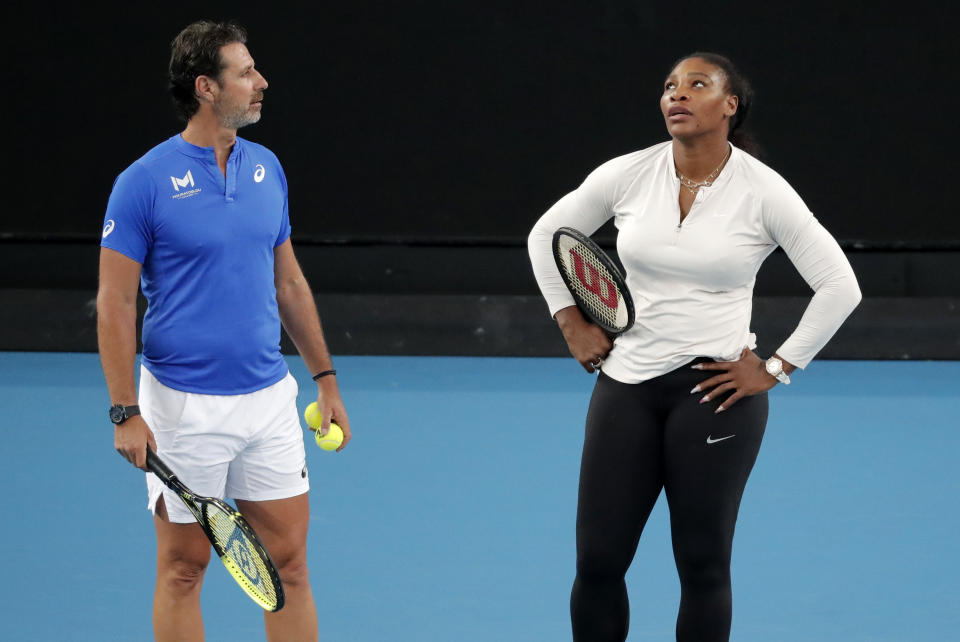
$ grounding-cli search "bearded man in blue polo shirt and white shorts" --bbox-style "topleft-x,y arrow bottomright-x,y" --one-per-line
97,22 -> 350,640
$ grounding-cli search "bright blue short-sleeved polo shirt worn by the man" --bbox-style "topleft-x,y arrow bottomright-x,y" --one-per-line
100,134 -> 290,395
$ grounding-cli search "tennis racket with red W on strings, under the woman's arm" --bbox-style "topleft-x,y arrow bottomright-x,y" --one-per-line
553,227 -> 634,335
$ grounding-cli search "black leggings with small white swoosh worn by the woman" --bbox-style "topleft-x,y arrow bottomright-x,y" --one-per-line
570,359 -> 767,642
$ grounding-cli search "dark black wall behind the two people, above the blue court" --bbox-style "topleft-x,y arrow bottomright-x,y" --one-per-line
0,0 -> 960,358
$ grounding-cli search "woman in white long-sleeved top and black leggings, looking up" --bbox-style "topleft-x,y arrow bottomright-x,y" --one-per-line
529,53 -> 860,642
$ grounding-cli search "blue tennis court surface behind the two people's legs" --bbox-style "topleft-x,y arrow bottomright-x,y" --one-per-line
0,352 -> 960,642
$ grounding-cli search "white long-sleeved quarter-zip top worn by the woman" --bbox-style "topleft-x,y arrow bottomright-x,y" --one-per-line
528,141 -> 861,383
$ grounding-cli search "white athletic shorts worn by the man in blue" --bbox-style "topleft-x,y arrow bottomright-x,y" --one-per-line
139,366 -> 310,524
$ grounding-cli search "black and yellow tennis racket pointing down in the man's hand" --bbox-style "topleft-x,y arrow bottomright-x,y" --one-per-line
147,448 -> 284,611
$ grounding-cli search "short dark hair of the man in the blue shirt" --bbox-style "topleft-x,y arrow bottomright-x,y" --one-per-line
168,20 -> 247,121
